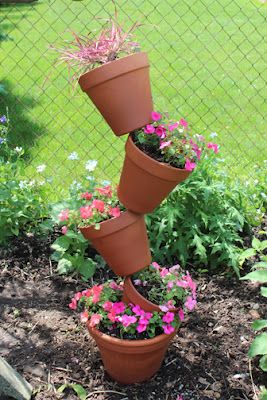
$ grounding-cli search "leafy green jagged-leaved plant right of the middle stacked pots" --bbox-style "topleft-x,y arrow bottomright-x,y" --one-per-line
146,158 -> 258,274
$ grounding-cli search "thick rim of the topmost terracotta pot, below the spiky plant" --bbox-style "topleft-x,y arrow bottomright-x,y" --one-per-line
78,52 -> 149,91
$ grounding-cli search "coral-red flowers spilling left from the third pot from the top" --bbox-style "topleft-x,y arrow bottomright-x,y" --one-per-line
58,185 -> 123,234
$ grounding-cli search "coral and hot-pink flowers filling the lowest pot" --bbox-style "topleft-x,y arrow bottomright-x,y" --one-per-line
69,281 -> 186,339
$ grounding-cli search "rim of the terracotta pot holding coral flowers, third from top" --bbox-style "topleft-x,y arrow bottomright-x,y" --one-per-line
79,210 -> 143,239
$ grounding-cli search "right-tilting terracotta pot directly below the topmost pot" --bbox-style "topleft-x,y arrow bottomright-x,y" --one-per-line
118,136 -> 190,214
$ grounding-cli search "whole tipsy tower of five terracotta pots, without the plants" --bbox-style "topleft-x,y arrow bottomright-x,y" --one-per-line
74,53 -> 193,384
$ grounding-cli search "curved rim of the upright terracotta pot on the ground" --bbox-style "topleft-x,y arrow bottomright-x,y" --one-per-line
87,322 -> 178,348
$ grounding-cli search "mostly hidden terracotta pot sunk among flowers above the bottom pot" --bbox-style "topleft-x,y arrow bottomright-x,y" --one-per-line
122,276 -> 177,312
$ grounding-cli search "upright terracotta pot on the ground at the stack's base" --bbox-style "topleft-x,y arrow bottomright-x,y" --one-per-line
88,325 -> 176,384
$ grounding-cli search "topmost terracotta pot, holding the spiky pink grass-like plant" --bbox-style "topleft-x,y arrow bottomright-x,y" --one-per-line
79,53 -> 153,136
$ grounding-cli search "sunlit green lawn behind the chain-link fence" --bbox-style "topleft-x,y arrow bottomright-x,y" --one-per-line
0,0 -> 267,197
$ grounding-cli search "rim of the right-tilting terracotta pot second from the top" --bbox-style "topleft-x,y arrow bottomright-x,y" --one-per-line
125,135 -> 190,181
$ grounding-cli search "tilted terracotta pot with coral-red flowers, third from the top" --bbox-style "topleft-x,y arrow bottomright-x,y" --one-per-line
80,211 -> 151,276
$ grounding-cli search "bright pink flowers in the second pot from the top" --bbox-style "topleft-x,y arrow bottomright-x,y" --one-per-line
132,111 -> 219,171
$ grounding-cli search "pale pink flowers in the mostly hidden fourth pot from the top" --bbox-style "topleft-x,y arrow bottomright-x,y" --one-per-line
132,262 -> 197,314
